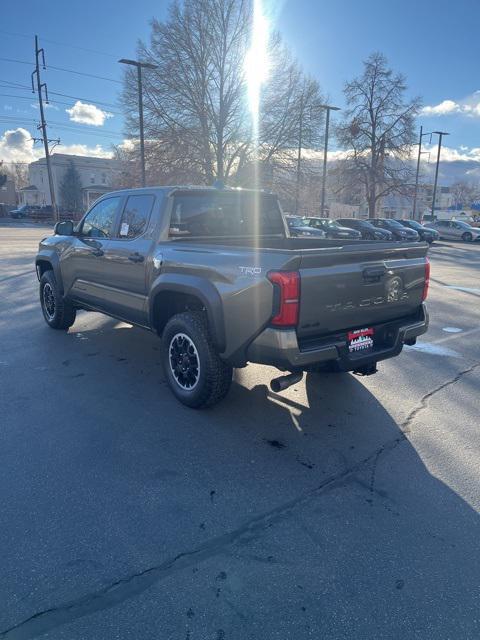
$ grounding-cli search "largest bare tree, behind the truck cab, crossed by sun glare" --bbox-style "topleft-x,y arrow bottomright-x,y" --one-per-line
123,0 -> 323,183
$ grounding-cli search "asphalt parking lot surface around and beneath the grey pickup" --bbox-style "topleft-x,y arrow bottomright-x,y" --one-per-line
0,223 -> 480,640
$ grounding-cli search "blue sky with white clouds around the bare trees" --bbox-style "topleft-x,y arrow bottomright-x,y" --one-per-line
0,0 -> 480,180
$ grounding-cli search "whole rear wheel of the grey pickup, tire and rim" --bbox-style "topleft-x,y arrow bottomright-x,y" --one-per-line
162,311 -> 232,409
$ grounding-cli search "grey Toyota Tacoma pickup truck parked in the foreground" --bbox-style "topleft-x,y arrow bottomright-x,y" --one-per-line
35,187 -> 430,408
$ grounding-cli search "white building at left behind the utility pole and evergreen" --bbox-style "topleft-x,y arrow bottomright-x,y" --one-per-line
20,153 -> 119,210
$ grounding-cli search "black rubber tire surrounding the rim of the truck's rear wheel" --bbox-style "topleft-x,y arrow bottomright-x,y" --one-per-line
162,311 -> 233,409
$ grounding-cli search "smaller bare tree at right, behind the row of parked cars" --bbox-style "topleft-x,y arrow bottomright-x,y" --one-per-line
337,53 -> 420,217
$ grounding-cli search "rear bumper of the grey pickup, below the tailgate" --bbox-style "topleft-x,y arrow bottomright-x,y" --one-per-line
247,303 -> 428,371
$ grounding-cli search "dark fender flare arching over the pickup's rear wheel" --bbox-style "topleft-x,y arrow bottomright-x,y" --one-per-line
148,273 -> 226,352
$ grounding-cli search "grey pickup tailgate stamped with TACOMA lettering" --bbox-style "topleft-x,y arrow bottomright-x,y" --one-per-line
297,243 -> 427,338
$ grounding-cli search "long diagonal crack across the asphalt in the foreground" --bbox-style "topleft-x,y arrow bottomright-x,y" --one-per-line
0,363 -> 480,640
